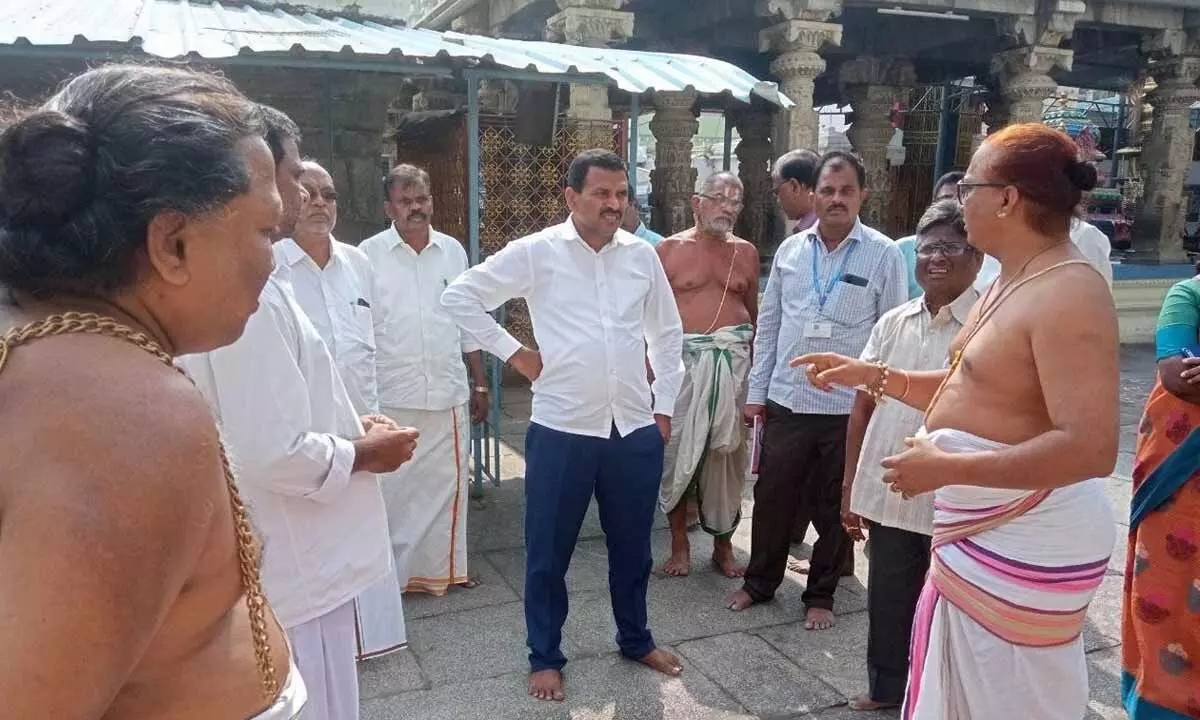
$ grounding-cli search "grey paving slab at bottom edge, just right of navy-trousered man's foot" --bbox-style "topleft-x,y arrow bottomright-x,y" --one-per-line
678,632 -> 845,718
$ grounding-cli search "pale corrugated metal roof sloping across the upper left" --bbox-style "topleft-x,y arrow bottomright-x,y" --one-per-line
0,0 -> 792,107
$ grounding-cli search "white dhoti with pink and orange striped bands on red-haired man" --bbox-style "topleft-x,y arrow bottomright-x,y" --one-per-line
902,430 -> 1114,720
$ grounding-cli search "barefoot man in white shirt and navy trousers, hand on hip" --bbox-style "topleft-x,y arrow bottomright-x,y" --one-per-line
442,150 -> 683,700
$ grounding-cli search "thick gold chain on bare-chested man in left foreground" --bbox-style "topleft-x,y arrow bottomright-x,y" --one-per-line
0,312 -> 280,700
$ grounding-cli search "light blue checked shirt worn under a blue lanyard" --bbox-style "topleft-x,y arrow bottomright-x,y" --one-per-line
746,221 -> 908,415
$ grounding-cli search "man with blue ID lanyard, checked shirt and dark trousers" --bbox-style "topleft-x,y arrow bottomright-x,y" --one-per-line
727,151 -> 908,630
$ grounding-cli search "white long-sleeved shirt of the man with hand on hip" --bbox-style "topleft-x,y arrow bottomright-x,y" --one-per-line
442,218 -> 683,438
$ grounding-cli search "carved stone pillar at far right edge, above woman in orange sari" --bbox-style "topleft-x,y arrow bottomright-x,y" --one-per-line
1134,55 -> 1200,262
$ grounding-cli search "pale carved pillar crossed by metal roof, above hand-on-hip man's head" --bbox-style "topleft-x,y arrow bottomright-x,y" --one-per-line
546,0 -> 634,131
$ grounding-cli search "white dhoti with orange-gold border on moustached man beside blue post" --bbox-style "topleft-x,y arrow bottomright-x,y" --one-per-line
380,404 -> 470,595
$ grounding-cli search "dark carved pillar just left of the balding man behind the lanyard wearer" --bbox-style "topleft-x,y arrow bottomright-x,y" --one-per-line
727,106 -> 776,256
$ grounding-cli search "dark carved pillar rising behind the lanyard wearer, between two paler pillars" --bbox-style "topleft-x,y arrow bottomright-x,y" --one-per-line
838,56 -> 917,229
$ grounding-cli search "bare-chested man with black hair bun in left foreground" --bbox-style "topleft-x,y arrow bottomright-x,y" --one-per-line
0,66 -> 305,720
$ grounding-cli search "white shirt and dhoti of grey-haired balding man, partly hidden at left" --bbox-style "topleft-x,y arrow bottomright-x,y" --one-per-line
275,239 -> 408,660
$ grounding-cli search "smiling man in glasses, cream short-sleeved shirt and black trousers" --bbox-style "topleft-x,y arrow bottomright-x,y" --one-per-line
841,199 -> 983,710
